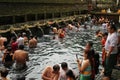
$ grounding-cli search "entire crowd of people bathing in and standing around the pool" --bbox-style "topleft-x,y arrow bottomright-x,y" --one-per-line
0,17 -> 120,80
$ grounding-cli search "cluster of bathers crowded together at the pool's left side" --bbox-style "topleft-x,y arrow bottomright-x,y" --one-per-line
0,32 -> 37,80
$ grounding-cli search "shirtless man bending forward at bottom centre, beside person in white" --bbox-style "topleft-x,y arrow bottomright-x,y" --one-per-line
42,64 -> 60,80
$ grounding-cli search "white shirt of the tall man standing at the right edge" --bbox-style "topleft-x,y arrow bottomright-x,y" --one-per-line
105,32 -> 118,54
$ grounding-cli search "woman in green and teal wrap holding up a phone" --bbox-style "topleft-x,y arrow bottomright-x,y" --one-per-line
77,50 -> 94,80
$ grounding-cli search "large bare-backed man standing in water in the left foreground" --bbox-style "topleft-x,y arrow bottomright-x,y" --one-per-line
13,45 -> 29,70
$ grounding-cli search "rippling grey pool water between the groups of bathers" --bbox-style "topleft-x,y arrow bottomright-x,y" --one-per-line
9,26 -> 101,80
